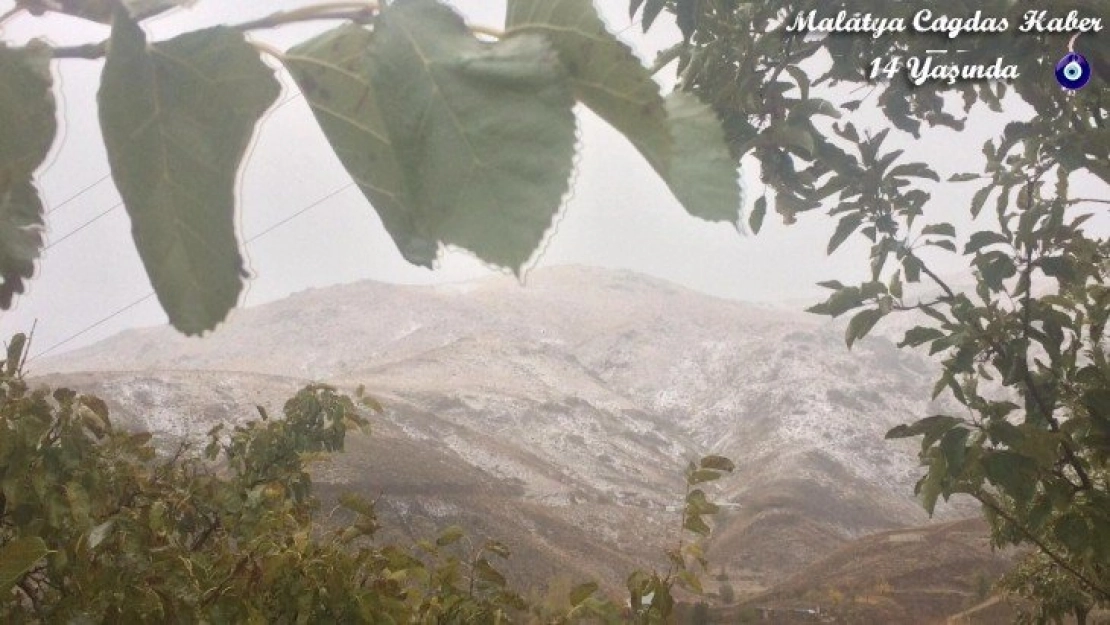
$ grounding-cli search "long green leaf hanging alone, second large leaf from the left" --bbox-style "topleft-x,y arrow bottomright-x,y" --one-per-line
99,12 -> 280,334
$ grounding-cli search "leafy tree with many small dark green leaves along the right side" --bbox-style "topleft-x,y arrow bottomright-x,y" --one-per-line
630,0 -> 1110,603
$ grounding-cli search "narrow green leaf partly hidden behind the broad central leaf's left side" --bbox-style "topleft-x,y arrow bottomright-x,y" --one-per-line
283,24 -> 437,268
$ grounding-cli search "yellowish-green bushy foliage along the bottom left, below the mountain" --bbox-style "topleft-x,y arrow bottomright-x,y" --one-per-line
0,335 -> 733,624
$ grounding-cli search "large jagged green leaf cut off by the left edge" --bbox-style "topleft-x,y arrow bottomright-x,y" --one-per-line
0,46 -> 58,309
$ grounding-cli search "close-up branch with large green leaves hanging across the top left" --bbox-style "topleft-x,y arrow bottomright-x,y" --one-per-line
0,0 -> 741,334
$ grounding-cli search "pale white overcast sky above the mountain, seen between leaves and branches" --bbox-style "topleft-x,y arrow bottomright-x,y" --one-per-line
0,0 -> 1110,359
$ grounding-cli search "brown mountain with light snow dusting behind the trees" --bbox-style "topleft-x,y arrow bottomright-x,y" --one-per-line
32,266 -> 973,591
